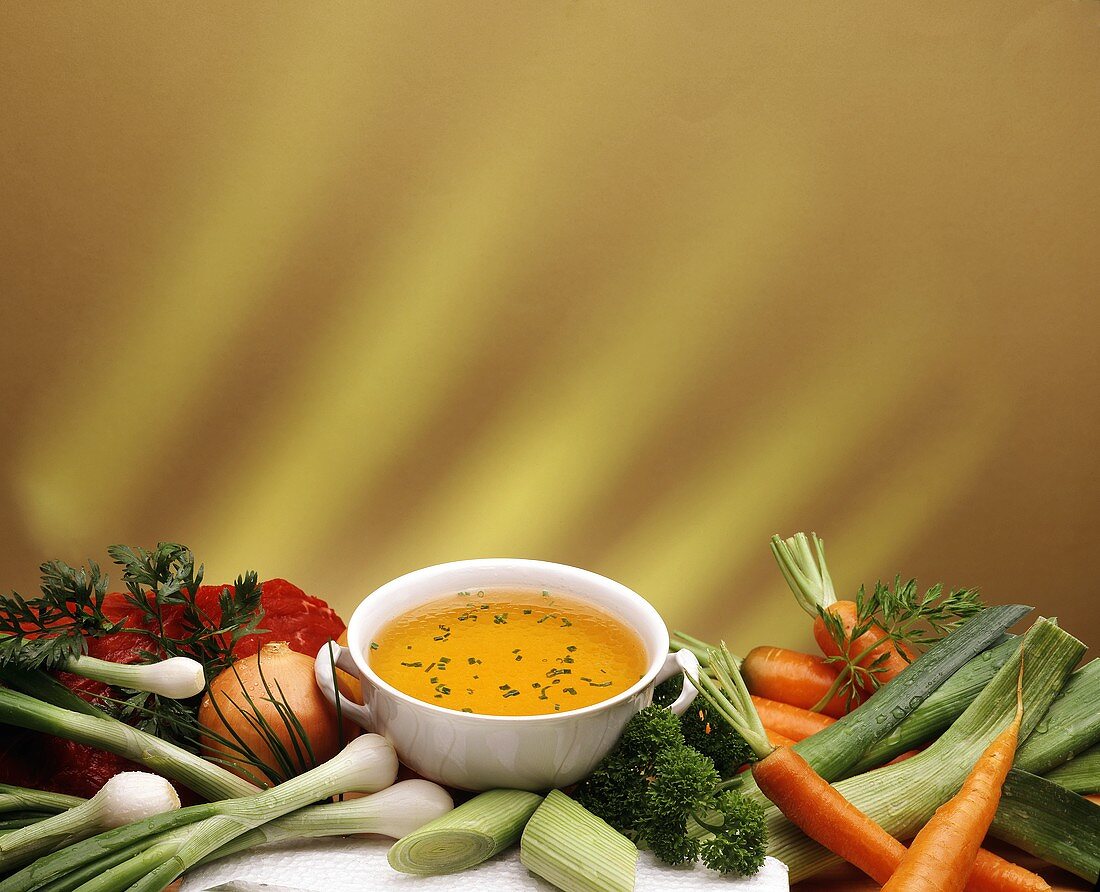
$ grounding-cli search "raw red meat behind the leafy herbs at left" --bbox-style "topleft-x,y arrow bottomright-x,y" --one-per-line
0,580 -> 345,796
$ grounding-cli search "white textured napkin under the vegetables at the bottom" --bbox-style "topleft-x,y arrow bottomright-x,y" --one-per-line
180,837 -> 790,892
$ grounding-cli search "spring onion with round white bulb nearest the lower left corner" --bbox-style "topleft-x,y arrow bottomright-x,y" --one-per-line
0,771 -> 179,872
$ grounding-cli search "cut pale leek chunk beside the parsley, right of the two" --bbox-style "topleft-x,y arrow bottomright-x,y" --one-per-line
519,790 -> 638,892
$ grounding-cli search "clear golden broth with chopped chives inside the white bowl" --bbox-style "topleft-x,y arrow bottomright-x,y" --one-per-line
370,587 -> 647,715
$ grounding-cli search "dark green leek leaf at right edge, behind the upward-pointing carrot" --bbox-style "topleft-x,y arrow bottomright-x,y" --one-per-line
990,769 -> 1100,883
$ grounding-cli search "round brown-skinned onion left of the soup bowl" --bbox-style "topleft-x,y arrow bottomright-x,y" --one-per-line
198,641 -> 360,783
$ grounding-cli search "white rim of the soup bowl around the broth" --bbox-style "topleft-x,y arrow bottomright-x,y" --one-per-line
348,558 -> 670,724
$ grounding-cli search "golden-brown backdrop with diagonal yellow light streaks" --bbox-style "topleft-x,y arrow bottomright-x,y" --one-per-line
0,2 -> 1100,650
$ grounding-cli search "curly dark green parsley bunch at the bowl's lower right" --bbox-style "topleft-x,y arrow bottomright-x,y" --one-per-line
574,706 -> 767,876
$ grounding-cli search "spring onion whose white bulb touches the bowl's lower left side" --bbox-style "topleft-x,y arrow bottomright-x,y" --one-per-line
0,734 -> 397,892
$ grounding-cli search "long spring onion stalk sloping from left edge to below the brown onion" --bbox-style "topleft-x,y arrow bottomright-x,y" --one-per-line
0,687 -> 257,800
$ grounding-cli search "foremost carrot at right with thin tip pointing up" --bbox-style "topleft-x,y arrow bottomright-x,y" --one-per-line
882,659 -> 1024,892
